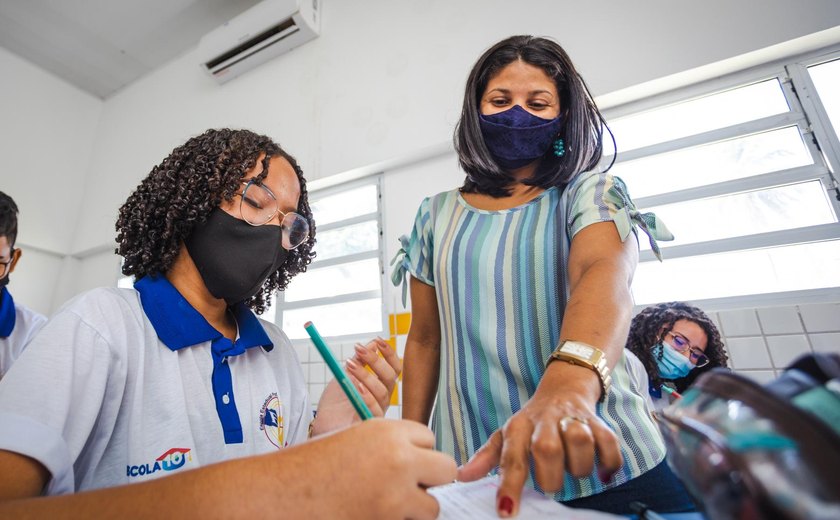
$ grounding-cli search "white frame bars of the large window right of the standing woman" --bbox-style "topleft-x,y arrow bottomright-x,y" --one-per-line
601,45 -> 840,309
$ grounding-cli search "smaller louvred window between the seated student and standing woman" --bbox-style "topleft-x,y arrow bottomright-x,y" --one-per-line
276,176 -> 385,339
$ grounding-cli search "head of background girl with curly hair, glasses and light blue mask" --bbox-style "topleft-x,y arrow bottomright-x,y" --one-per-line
626,302 -> 728,409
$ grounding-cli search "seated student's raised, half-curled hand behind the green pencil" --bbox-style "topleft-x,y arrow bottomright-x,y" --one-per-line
312,338 -> 402,435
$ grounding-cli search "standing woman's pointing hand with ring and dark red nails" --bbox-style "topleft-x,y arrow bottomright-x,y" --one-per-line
458,361 -> 622,517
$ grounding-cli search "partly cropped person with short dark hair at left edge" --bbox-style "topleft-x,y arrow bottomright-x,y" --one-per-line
0,191 -> 47,379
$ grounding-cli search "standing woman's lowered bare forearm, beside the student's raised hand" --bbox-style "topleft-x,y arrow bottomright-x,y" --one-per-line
402,338 -> 440,424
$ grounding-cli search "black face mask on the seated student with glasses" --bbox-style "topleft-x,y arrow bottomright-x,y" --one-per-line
184,208 -> 289,305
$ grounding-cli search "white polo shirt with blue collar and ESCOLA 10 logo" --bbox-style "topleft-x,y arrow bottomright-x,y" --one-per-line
0,276 -> 311,495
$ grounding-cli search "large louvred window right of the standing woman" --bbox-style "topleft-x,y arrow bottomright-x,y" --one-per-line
605,47 -> 840,305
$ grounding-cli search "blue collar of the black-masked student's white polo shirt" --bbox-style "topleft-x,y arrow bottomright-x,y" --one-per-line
134,274 -> 274,351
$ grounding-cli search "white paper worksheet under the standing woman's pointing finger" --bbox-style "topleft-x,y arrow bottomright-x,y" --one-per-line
429,475 -> 623,520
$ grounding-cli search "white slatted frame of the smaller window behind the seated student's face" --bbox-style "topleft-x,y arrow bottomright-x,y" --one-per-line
274,172 -> 388,344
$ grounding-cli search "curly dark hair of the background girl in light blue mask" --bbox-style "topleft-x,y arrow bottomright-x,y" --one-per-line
625,302 -> 729,392
